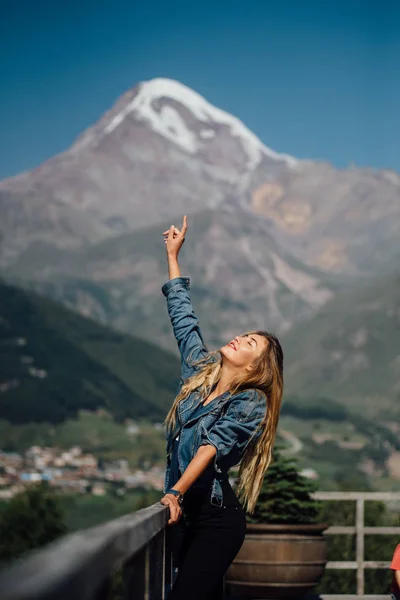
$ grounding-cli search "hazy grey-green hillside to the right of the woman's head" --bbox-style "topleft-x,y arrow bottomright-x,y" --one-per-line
284,276 -> 400,420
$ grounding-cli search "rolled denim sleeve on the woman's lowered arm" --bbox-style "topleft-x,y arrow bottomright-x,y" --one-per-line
200,390 -> 266,463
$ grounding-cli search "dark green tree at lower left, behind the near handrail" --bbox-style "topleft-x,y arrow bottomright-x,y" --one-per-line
0,482 -> 66,562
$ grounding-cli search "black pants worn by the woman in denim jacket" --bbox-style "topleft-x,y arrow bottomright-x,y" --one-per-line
168,481 -> 246,600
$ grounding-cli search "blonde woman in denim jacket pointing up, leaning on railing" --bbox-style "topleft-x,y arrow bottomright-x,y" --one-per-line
161,216 -> 283,600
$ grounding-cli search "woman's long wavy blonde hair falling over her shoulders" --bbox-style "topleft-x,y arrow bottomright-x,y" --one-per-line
164,331 -> 283,514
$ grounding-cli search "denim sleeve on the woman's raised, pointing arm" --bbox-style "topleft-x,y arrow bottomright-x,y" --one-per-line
161,277 -> 208,380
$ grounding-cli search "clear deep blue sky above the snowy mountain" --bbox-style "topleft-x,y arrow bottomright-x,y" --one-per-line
0,0 -> 400,177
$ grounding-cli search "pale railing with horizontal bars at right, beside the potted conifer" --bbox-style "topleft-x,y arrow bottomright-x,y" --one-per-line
313,492 -> 400,600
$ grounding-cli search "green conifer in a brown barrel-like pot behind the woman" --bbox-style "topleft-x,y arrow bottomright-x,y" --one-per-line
225,450 -> 327,598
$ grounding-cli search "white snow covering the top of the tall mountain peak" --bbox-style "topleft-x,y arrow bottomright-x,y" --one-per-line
104,77 -> 298,169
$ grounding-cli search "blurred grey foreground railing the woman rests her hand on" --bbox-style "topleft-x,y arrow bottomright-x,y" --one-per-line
0,503 -> 172,600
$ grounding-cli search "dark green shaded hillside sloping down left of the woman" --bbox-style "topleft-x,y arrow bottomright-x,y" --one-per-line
0,282 -> 179,423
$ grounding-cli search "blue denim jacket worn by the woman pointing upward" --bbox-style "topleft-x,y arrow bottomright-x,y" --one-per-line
162,277 -> 266,506
